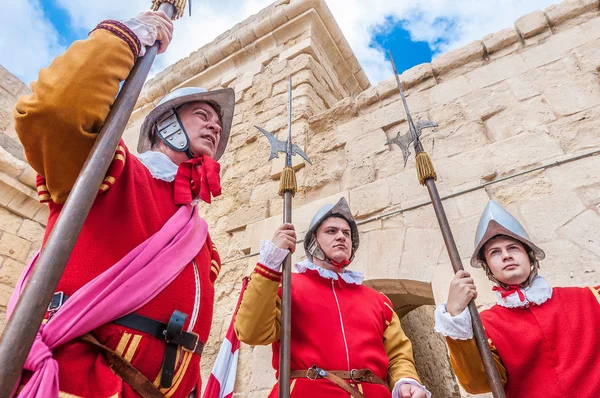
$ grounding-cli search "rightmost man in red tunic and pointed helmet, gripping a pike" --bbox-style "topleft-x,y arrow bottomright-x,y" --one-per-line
435,201 -> 600,398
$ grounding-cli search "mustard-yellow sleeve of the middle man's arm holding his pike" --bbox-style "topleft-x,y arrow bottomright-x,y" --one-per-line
234,264 -> 281,345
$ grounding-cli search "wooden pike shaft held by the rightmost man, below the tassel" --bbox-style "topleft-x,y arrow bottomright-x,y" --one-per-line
422,180 -> 505,398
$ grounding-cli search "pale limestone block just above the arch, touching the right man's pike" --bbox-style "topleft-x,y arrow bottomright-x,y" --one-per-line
400,228 -> 444,282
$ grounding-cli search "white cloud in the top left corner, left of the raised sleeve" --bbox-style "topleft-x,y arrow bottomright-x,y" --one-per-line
0,0 -> 64,83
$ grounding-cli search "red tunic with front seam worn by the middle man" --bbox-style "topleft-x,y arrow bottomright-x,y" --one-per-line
269,270 -> 393,398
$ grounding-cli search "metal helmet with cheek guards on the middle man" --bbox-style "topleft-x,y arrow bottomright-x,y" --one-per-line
304,198 -> 359,262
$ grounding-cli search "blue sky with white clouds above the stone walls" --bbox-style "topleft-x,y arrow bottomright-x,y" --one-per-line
0,0 -> 556,84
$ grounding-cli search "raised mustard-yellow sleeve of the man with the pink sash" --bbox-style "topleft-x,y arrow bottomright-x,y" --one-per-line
13,29 -> 135,203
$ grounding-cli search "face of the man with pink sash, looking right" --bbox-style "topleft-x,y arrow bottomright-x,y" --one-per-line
179,102 -> 222,158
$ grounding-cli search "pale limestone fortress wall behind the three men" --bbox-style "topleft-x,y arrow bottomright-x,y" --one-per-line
0,0 -> 600,398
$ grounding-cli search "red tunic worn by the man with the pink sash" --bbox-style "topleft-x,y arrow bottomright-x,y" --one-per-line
28,144 -> 220,397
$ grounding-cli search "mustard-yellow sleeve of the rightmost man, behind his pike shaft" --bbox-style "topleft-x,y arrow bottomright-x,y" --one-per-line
446,337 -> 508,394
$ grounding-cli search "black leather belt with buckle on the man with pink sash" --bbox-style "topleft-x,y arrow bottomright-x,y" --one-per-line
48,292 -> 204,388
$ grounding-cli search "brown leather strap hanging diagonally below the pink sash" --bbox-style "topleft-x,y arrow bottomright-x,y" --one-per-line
79,333 -> 165,398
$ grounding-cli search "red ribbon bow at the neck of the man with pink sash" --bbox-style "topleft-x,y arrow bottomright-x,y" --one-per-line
174,155 -> 221,205
